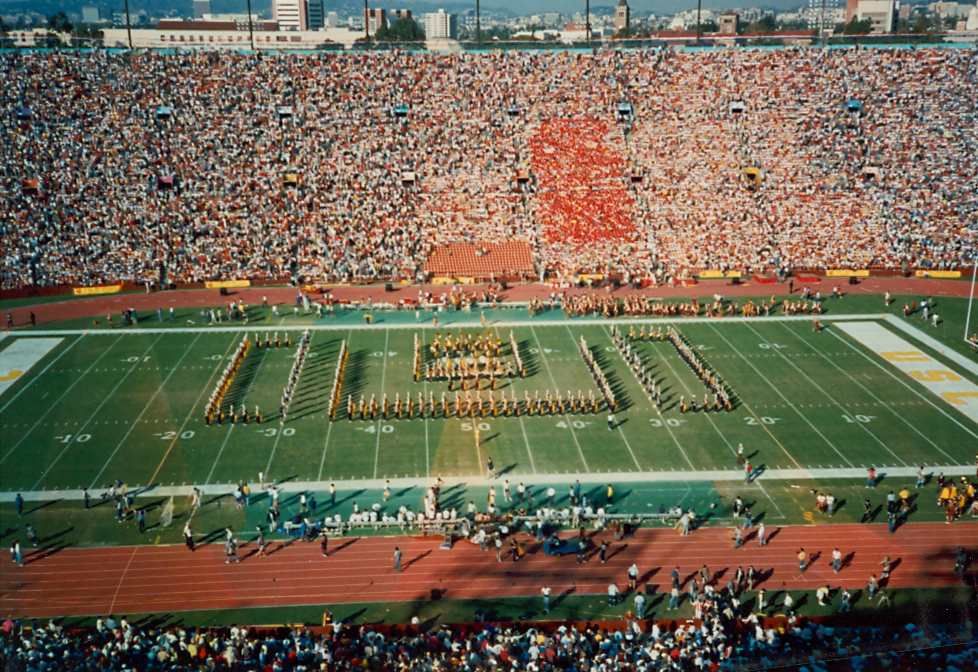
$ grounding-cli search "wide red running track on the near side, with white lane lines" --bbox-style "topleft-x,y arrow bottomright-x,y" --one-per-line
0,522 -> 978,618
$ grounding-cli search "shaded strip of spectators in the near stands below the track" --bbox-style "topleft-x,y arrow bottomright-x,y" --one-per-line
0,615 -> 978,672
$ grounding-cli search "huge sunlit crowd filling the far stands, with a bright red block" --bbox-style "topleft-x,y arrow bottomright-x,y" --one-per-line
0,48 -> 978,288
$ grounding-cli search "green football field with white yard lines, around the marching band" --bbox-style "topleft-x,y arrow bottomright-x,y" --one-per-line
0,297 -> 978,493
